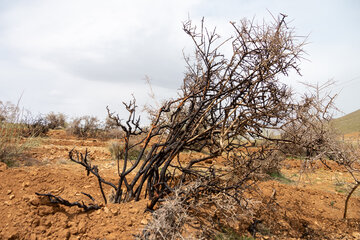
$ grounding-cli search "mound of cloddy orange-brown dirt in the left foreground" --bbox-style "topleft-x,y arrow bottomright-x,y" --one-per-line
0,165 -> 149,239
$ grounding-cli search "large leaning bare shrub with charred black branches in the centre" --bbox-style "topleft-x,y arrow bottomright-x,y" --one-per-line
37,13 -> 304,234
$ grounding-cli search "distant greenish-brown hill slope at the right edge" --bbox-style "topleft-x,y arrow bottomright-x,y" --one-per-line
334,109 -> 360,134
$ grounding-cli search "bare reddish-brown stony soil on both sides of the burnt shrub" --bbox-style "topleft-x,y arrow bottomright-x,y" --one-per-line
0,130 -> 360,240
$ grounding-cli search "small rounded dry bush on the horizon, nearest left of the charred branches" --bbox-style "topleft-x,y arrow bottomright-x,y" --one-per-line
66,116 -> 103,138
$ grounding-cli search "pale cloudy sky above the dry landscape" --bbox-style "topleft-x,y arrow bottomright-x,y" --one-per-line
0,0 -> 360,122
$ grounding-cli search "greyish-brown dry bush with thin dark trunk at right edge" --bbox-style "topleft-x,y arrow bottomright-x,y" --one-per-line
280,81 -> 360,218
